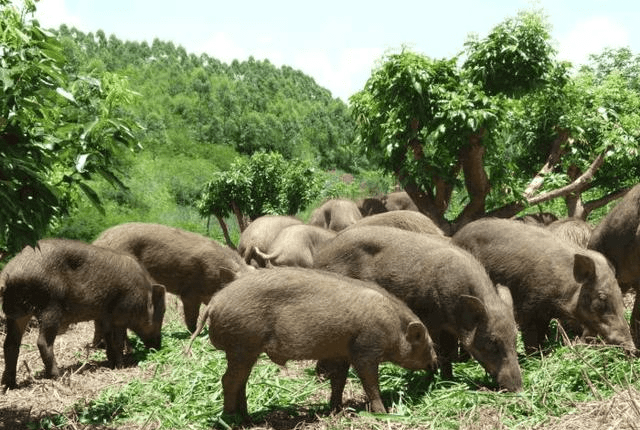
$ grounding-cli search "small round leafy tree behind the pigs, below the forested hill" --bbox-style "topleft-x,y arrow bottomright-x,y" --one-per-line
196,152 -> 320,247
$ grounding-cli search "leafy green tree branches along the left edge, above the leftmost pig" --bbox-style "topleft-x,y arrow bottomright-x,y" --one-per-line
0,0 -> 139,257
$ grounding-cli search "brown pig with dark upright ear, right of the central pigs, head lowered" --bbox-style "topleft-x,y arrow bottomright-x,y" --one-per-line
453,219 -> 634,352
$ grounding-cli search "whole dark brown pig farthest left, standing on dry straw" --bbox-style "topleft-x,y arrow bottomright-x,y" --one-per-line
0,239 -> 165,388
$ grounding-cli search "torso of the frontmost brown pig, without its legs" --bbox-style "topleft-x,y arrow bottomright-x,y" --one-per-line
208,267 -> 419,363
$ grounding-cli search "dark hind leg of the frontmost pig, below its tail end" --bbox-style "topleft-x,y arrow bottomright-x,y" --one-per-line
222,351 -> 259,418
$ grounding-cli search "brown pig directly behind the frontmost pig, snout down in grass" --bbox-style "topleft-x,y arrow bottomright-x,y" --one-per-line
314,226 -> 522,391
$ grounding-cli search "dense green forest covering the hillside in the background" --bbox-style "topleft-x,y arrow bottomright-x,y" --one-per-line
57,26 -> 366,171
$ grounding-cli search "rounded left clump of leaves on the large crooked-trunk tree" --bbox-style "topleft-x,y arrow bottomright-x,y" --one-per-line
351,49 -> 497,197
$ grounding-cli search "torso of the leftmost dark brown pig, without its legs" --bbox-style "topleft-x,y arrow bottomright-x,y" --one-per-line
3,239 -> 156,323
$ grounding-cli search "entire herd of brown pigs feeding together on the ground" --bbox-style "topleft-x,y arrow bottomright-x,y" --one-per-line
0,184 -> 640,416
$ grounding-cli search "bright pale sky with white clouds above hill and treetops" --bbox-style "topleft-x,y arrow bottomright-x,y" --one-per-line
36,0 -> 640,102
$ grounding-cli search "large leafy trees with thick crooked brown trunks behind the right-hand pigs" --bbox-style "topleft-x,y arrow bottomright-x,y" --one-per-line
351,11 -> 640,233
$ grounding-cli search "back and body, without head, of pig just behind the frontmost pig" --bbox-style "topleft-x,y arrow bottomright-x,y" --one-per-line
314,226 -> 497,329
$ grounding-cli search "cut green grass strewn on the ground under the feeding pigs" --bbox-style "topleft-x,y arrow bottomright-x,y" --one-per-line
39,319 -> 640,429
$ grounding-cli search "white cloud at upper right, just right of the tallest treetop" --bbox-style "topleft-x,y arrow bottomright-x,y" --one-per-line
558,17 -> 629,66
